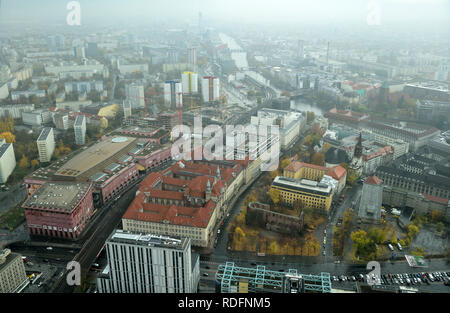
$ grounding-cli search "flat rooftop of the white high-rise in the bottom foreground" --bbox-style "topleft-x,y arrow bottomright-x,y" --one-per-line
107,229 -> 188,250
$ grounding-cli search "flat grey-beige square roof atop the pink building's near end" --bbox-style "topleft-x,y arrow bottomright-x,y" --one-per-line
23,182 -> 91,213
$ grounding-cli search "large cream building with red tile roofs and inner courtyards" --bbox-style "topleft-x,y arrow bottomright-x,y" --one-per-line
122,160 -> 245,247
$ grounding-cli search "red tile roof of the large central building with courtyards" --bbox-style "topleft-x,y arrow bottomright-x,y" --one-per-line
124,161 -> 248,227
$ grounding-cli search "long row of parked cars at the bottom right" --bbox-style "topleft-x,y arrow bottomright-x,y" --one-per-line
332,272 -> 450,286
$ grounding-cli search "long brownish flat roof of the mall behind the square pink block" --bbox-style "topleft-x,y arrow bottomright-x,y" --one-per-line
55,136 -> 137,179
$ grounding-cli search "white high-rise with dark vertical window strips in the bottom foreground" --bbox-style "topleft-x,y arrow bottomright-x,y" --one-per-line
97,230 -> 200,293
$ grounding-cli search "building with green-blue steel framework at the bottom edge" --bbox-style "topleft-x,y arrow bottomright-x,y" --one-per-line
216,262 -> 331,293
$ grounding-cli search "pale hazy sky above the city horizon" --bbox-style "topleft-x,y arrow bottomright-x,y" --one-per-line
0,0 -> 450,26
